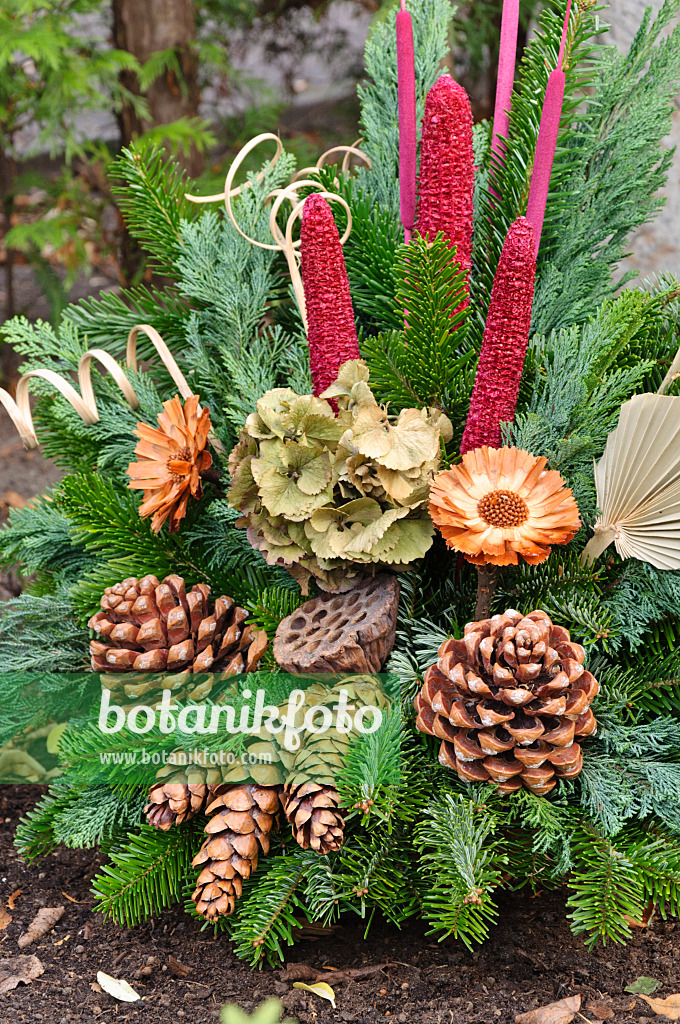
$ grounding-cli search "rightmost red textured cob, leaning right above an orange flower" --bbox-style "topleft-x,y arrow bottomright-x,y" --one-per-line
461,217 -> 536,455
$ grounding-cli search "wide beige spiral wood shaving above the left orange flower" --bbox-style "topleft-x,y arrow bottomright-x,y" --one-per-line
0,324 -> 193,449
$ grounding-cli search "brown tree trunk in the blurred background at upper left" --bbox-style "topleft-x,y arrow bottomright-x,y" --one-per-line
113,0 -> 204,177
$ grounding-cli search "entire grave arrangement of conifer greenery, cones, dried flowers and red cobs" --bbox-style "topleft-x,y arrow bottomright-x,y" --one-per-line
0,0 -> 680,965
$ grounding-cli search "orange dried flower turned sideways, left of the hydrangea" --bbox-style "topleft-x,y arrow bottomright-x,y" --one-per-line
127,394 -> 212,534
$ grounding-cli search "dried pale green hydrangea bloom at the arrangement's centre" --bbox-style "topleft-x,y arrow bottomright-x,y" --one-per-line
228,359 -> 452,594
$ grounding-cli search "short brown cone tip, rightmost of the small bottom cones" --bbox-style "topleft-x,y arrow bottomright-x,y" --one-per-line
284,779 -> 345,854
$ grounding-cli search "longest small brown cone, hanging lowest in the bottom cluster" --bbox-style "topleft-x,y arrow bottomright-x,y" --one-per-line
192,782 -> 281,921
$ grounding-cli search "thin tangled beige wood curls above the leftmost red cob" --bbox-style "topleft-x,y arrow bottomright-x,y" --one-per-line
186,132 -> 371,330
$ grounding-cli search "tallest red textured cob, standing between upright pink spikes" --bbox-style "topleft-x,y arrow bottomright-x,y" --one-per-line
416,75 -> 474,278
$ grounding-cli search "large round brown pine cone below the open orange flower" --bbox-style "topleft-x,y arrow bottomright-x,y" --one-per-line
416,609 -> 599,796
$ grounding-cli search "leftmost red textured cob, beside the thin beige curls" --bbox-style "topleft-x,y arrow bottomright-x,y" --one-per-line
300,195 -> 359,395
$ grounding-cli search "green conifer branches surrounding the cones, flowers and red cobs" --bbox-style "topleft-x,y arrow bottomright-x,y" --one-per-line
0,0 -> 680,966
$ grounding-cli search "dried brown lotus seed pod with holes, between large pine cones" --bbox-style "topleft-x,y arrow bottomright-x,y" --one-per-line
273,573 -> 399,673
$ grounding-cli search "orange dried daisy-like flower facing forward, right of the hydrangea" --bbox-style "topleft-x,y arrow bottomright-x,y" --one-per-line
430,445 -> 581,565
